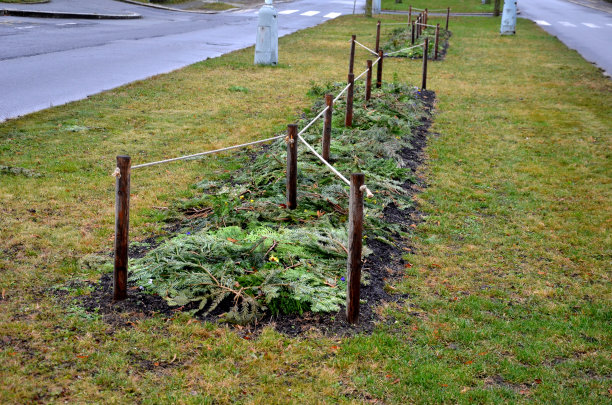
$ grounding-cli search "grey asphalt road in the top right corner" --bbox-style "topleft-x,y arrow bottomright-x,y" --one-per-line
517,0 -> 612,75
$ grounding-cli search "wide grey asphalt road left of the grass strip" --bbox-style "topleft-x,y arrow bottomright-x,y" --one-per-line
0,0 -> 365,122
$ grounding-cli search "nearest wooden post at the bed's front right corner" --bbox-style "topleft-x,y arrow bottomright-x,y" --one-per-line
346,173 -> 364,324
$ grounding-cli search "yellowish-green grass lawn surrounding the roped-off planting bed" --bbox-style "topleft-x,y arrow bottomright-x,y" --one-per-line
0,16 -> 612,404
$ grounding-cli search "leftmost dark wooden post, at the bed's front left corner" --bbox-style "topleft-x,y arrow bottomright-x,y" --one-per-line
113,155 -> 131,301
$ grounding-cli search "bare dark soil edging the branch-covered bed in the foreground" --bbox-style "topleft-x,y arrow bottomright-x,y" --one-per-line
64,90 -> 435,336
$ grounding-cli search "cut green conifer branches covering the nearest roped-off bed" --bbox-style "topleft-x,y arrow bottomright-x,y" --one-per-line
131,83 -> 427,324
